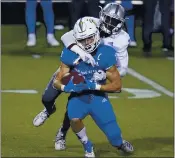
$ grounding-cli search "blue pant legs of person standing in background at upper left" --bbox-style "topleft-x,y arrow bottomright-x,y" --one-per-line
26,0 -> 54,33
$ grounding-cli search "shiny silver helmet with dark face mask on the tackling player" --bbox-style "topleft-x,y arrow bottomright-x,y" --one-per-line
99,3 -> 125,34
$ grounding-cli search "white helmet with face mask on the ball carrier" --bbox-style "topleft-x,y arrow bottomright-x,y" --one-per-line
73,17 -> 100,53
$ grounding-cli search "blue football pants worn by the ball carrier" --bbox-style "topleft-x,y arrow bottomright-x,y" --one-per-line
67,96 -> 122,147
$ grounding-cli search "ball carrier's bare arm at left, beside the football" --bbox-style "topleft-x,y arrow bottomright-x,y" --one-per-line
53,63 -> 70,91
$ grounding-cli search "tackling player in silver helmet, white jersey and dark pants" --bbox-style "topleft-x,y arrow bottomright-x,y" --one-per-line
33,3 -> 129,150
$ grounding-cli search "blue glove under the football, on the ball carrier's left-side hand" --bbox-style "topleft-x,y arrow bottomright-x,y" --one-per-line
61,77 -> 88,93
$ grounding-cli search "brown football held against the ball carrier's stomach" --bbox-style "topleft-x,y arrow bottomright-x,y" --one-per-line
61,71 -> 85,85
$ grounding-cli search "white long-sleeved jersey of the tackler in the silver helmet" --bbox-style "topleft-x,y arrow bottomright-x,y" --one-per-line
61,17 -> 130,77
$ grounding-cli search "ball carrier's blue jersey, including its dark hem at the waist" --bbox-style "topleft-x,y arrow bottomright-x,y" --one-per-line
61,45 -> 117,103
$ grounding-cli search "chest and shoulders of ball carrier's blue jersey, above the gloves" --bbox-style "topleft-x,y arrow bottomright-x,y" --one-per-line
61,44 -> 117,84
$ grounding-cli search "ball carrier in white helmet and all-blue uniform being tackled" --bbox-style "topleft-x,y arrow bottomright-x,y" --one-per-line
53,18 -> 133,157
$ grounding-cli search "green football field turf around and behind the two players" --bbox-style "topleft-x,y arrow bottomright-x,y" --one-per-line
1,25 -> 174,157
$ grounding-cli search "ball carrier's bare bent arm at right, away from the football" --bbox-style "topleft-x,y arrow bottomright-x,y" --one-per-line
100,65 -> 122,92
